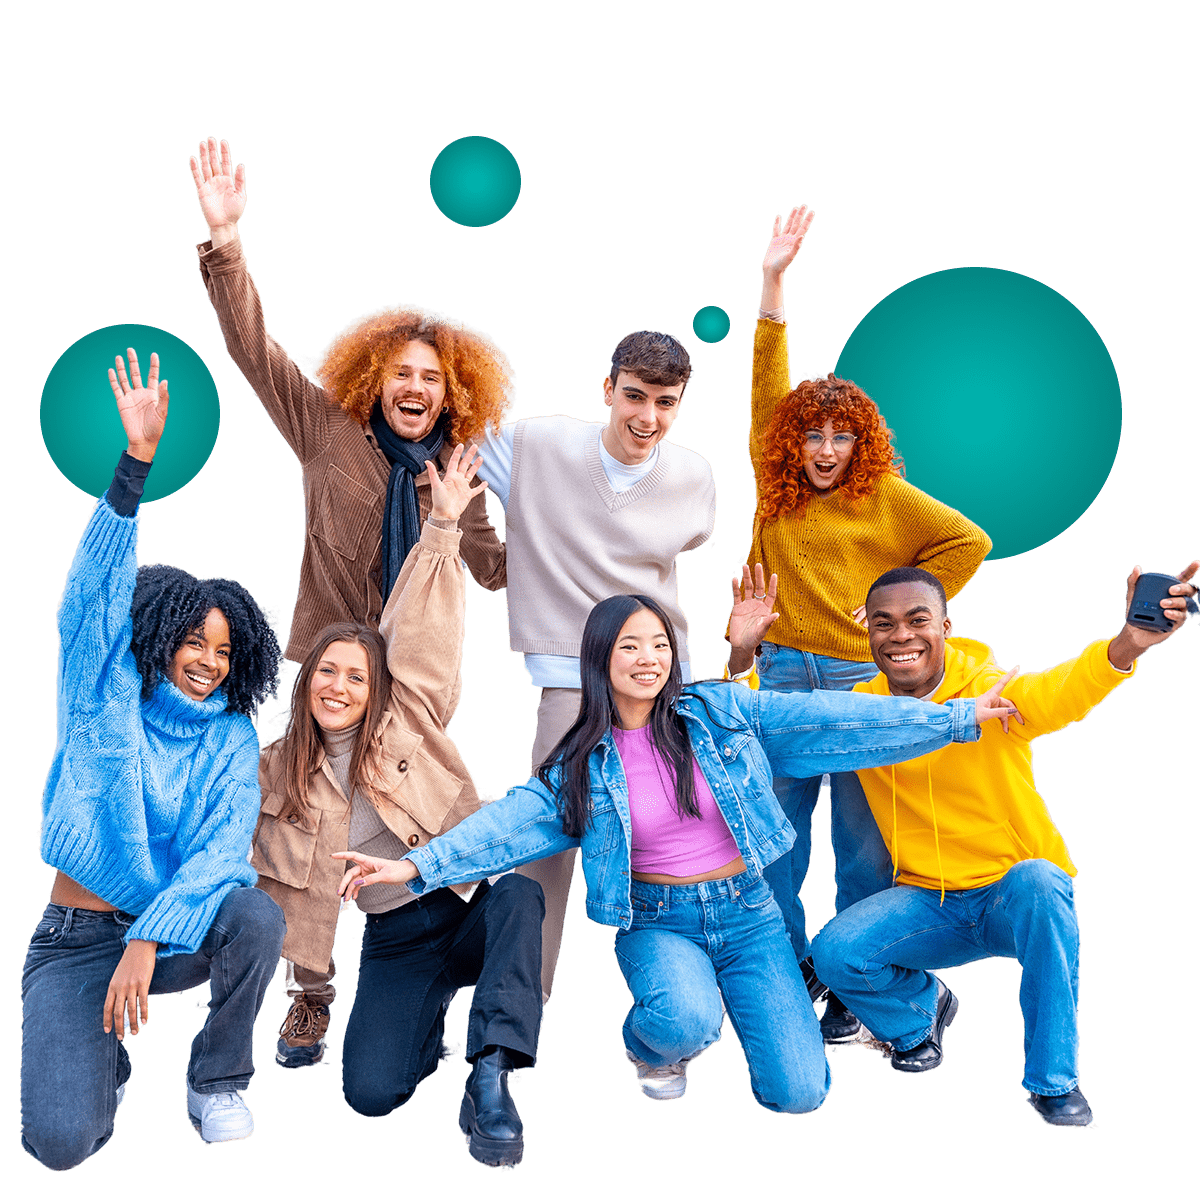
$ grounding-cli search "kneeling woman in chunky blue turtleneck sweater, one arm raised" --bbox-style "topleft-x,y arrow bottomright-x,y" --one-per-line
20,349 -> 283,1170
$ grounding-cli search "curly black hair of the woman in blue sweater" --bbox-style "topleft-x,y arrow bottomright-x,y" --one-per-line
130,563 -> 283,718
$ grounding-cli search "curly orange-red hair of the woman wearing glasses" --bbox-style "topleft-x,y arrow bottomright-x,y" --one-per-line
756,371 -> 904,523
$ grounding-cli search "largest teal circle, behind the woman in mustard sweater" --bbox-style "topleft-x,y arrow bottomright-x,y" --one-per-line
836,266 -> 1121,558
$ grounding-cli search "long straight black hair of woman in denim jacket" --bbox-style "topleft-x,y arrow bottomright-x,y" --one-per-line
538,595 -> 700,838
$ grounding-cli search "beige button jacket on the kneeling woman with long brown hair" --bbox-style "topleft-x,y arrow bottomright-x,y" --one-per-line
252,522 -> 480,971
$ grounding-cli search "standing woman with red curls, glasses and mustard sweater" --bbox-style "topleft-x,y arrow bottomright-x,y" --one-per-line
731,205 -> 991,1042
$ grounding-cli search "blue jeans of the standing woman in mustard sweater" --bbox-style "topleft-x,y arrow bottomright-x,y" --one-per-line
758,642 -> 892,960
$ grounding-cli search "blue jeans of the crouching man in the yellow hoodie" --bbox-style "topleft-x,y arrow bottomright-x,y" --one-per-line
812,858 -> 1079,1096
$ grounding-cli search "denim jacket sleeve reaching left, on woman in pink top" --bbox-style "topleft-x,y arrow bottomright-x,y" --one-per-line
408,775 -> 580,894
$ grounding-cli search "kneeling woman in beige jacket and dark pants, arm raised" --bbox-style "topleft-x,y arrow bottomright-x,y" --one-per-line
253,446 -> 544,1168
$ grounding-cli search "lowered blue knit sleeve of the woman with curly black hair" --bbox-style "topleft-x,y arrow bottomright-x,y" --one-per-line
126,716 -> 260,956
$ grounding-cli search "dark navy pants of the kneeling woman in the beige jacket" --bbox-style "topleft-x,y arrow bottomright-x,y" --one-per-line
342,875 -> 546,1117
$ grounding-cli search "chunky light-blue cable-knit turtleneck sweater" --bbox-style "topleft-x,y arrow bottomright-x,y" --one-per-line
41,499 -> 259,955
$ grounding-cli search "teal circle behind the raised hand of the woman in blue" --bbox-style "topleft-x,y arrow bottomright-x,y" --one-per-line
41,325 -> 221,500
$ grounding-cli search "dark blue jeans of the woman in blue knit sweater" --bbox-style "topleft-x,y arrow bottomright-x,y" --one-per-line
20,888 -> 284,1171
